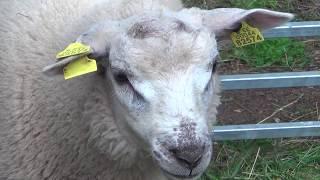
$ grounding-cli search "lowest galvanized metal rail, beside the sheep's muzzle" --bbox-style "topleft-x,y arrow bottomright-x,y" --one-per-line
212,121 -> 320,141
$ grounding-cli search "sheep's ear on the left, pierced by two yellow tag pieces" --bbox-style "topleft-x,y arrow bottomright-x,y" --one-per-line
42,21 -> 121,76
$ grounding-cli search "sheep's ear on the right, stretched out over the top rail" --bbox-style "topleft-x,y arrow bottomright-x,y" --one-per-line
201,8 -> 294,39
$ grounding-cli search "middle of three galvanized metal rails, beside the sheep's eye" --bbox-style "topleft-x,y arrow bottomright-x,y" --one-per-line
220,71 -> 320,90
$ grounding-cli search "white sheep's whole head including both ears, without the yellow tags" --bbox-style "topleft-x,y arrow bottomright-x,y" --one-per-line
45,8 -> 293,179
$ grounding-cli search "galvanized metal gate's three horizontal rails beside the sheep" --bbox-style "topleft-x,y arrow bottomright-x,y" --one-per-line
212,21 -> 320,141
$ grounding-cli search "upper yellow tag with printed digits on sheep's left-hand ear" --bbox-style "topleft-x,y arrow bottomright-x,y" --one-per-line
56,42 -> 91,59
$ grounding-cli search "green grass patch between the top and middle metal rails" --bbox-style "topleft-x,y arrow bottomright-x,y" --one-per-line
221,38 -> 310,69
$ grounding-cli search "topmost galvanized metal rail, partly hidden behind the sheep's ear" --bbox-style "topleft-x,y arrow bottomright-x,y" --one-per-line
263,21 -> 320,38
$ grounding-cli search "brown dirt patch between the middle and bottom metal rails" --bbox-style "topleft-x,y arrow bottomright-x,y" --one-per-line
218,87 -> 320,124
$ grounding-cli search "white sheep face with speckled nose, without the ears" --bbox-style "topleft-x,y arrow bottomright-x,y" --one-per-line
106,18 -> 218,178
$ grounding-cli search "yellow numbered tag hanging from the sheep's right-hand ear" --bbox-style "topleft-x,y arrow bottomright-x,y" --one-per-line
231,22 -> 264,48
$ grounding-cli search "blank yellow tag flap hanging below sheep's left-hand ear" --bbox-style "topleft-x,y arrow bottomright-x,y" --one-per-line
63,56 -> 97,80
